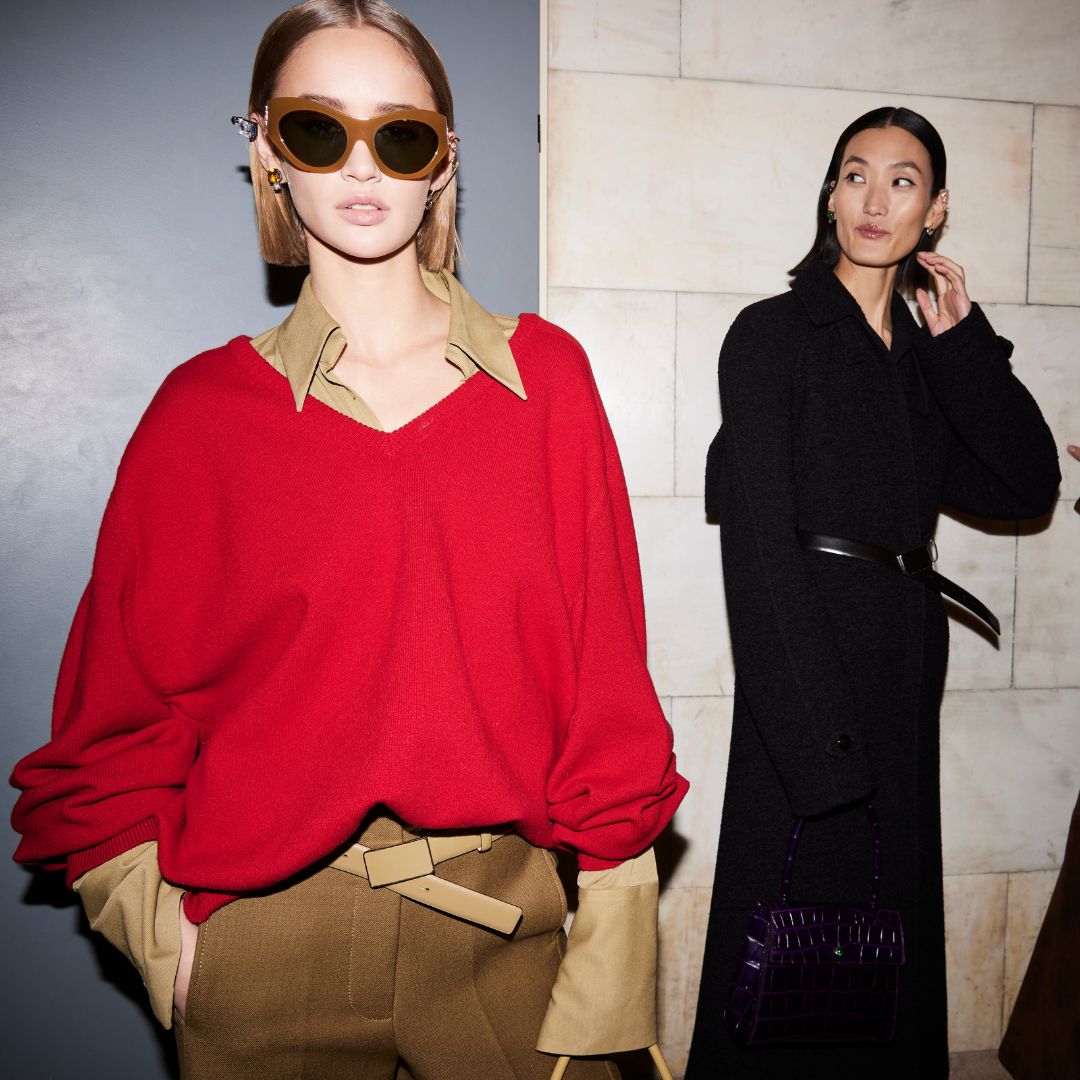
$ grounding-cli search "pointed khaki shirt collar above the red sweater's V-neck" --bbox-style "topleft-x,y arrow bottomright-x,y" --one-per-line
270,268 -> 526,411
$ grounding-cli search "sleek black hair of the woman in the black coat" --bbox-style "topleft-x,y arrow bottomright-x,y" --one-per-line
787,105 -> 945,296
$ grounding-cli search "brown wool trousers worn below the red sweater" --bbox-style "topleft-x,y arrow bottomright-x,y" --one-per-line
174,818 -> 618,1080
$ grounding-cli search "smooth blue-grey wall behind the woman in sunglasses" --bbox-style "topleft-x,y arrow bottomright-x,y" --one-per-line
0,0 -> 539,1078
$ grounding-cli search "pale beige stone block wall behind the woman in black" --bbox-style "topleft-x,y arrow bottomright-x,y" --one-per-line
546,0 -> 1080,1070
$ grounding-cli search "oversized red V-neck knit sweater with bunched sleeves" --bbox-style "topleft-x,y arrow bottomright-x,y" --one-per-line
12,315 -> 687,921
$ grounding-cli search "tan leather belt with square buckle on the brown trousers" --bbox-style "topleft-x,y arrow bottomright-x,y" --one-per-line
329,833 -> 522,934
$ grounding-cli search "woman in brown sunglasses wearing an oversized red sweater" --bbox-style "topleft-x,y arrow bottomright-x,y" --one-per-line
13,0 -> 686,1080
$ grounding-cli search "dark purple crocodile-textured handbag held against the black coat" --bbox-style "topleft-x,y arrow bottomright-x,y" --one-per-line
724,802 -> 904,1047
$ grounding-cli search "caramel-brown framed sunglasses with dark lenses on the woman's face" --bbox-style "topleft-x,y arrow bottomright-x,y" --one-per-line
266,97 -> 449,180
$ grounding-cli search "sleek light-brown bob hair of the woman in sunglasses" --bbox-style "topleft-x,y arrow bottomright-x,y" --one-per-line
247,0 -> 461,272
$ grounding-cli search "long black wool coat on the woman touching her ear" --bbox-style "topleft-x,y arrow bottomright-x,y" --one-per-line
687,264 -> 1061,1080
